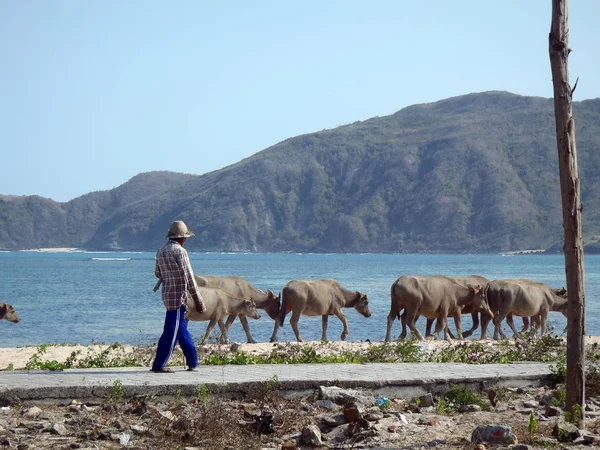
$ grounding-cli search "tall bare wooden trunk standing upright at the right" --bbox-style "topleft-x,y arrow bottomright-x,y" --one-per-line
549,0 -> 585,428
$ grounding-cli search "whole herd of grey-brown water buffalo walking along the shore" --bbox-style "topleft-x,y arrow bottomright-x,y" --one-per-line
0,275 -> 567,344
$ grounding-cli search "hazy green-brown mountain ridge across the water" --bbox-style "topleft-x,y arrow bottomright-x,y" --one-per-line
0,92 -> 600,252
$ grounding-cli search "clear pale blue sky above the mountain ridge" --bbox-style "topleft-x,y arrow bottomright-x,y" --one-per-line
0,0 -> 600,201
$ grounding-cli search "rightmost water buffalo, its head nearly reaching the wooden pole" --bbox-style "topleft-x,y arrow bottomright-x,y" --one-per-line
481,279 -> 568,339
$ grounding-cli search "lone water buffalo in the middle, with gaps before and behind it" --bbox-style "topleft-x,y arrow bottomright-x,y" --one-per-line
271,279 -> 371,342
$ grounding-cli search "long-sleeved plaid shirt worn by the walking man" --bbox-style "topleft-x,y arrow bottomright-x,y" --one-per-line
154,240 -> 205,311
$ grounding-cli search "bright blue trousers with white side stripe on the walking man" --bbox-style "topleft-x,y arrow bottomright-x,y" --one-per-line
152,306 -> 198,370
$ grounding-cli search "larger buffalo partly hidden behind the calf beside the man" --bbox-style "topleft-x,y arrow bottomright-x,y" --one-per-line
194,275 -> 281,344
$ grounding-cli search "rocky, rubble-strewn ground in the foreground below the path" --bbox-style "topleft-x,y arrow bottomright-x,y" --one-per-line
0,384 -> 600,450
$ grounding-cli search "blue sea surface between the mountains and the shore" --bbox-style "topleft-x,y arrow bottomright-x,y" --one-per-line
0,251 -> 600,347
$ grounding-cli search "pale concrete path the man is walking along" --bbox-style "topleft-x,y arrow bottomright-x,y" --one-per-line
0,363 -> 552,406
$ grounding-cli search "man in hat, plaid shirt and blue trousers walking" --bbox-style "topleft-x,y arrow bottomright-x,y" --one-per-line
151,220 -> 206,373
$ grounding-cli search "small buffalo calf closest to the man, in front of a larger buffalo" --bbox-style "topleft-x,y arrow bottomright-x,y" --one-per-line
185,286 -> 260,345
